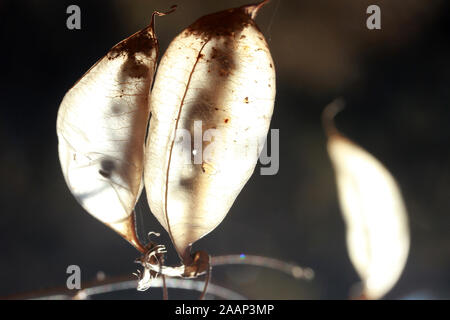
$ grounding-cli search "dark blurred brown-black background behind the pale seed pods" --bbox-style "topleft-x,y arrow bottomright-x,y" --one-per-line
0,0 -> 450,299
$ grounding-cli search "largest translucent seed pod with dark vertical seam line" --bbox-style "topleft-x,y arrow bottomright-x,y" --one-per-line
144,1 -> 275,264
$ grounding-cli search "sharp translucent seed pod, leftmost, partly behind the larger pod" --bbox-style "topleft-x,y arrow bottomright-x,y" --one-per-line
57,13 -> 168,251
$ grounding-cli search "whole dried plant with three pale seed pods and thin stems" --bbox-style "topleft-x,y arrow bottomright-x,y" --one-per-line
51,0 -> 409,299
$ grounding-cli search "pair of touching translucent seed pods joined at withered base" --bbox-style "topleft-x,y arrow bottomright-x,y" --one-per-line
57,1 -> 275,287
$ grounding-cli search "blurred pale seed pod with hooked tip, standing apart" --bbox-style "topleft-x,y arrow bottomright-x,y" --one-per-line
323,101 -> 410,299
